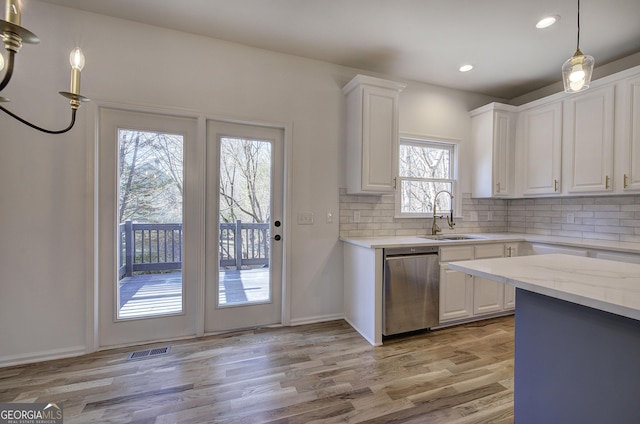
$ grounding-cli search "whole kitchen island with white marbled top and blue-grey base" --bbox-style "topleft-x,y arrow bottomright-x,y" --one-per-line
449,254 -> 640,424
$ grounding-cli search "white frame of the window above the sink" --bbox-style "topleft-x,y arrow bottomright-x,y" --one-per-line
394,134 -> 462,218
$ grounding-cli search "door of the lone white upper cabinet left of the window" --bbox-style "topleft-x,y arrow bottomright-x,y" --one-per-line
362,86 -> 399,193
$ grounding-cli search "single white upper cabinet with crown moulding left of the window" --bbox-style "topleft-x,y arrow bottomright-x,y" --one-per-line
342,75 -> 406,194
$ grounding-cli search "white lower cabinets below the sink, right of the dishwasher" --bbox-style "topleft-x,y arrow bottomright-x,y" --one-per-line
440,243 -> 517,325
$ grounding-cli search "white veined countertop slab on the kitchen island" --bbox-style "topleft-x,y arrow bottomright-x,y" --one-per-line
449,254 -> 640,320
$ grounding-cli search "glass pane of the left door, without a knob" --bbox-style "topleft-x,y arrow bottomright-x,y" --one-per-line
117,129 -> 184,319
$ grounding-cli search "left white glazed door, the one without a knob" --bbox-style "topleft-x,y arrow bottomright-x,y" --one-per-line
96,108 -> 202,347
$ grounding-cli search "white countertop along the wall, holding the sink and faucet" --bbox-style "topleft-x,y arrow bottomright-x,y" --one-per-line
340,233 -> 640,254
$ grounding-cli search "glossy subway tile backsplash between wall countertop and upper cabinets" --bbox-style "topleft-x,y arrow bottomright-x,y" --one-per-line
340,189 -> 640,242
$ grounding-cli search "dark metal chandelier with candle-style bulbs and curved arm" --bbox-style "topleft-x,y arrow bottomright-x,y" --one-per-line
0,0 -> 89,134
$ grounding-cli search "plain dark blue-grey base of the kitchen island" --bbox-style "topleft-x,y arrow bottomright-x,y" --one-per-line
514,289 -> 640,424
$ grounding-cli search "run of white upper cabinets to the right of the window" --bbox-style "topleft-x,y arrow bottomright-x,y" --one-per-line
470,66 -> 640,198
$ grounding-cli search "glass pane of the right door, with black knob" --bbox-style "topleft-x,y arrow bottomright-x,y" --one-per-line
217,137 -> 271,307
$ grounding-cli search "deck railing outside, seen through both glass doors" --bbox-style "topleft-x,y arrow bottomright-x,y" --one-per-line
119,221 -> 269,277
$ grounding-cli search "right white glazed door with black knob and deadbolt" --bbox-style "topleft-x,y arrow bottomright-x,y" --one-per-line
204,120 -> 284,333
